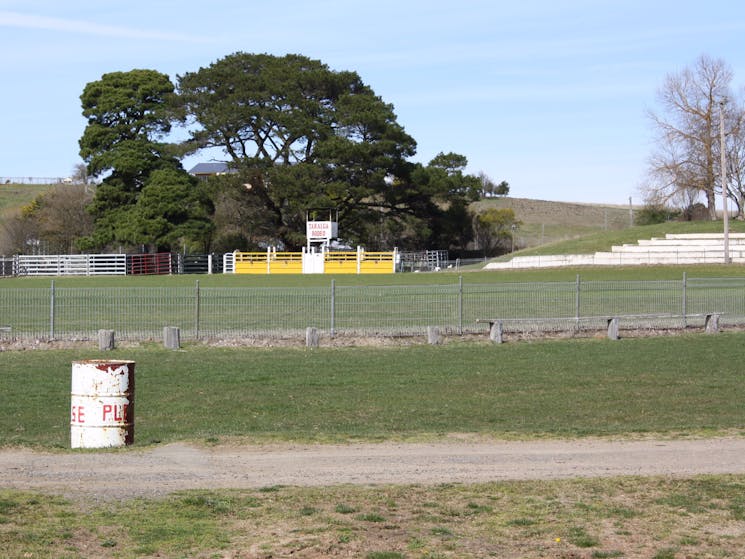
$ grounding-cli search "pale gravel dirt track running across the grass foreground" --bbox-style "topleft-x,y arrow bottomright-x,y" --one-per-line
0,438 -> 745,499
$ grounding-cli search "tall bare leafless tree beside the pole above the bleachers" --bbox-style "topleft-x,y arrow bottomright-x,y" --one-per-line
647,55 -> 732,219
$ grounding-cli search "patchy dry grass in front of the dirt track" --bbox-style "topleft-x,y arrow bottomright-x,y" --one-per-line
0,476 -> 745,559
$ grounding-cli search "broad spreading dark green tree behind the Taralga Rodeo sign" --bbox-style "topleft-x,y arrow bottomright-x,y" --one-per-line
178,53 -> 478,249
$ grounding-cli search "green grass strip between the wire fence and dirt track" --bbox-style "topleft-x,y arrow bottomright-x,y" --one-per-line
0,333 -> 745,448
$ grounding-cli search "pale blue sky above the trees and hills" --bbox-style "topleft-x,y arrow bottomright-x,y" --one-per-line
0,0 -> 745,204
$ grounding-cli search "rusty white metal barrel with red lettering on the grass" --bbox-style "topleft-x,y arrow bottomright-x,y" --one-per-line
70,359 -> 135,448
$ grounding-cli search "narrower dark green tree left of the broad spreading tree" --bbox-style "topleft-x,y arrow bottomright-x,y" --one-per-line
79,70 -> 211,250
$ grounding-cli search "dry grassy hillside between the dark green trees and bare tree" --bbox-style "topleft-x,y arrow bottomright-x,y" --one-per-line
471,197 -> 632,248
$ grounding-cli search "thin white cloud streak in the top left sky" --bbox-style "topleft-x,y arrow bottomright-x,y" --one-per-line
0,11 -> 206,42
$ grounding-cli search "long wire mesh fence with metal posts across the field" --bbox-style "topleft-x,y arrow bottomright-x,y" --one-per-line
0,276 -> 745,341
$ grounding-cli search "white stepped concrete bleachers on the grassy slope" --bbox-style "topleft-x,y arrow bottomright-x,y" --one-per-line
484,233 -> 745,270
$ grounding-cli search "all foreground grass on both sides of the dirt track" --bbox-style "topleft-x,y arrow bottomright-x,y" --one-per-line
0,332 -> 745,559
